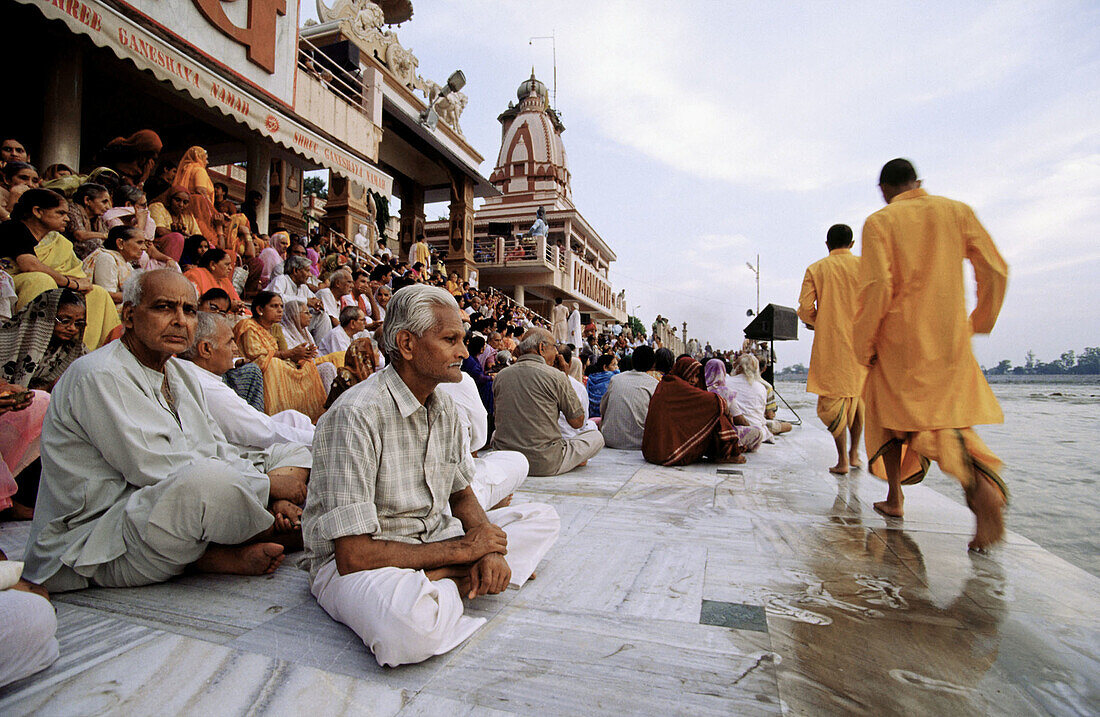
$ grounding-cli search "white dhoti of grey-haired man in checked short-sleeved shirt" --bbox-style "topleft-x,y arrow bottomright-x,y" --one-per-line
312,503 -> 561,668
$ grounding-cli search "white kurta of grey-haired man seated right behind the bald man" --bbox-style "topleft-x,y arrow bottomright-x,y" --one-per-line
183,361 -> 314,451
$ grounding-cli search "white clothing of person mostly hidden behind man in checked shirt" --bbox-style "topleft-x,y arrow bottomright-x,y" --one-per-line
438,372 -> 528,510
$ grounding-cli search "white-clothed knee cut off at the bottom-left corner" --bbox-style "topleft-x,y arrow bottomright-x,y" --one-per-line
0,589 -> 57,687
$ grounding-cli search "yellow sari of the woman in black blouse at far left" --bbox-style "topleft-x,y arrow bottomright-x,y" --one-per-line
8,232 -> 122,351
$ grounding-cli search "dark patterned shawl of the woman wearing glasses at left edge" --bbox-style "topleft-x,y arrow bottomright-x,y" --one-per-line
0,289 -> 85,388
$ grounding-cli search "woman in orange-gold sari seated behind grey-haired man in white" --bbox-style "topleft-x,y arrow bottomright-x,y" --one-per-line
233,291 -> 343,423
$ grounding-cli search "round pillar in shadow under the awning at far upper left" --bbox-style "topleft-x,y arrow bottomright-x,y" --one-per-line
40,43 -> 84,172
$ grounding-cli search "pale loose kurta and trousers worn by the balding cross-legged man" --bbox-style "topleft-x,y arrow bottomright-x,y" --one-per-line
24,341 -> 273,592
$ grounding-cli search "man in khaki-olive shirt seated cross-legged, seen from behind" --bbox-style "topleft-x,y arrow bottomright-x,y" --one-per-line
493,329 -> 604,475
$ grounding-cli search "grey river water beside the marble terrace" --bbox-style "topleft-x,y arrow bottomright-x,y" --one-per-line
777,376 -> 1100,576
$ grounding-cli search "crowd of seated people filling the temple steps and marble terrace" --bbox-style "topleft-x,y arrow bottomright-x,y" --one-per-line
0,130 -> 790,684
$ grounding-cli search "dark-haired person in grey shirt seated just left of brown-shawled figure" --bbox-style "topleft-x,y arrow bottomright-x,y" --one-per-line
600,346 -> 659,451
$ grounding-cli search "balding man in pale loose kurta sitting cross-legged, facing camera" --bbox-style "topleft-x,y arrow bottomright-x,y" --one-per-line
24,269 -> 309,592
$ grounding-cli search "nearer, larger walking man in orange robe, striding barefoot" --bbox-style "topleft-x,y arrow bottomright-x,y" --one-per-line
854,159 -> 1008,550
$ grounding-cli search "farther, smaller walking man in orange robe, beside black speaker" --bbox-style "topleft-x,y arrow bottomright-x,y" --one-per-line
799,224 -> 867,475
